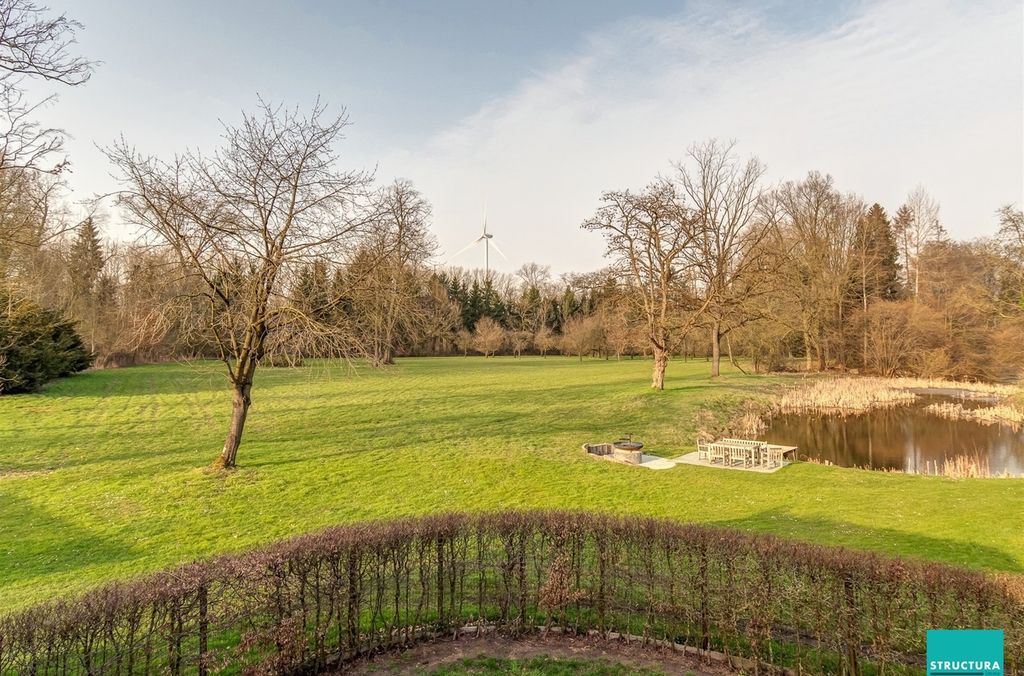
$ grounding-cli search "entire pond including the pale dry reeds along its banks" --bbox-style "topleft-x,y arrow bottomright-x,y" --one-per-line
765,378 -> 1024,478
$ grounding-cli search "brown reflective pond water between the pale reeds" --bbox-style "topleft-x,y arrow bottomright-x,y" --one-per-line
764,392 -> 1024,476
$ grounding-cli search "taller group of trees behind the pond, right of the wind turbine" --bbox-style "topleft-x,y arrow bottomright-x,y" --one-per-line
583,140 -> 1024,388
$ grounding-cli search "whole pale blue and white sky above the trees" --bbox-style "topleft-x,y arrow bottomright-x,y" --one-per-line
25,0 -> 1024,273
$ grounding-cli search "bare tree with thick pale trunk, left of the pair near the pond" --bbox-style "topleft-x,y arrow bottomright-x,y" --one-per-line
583,180 -> 712,389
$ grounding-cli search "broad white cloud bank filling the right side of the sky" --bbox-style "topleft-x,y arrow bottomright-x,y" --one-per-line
379,0 -> 1024,271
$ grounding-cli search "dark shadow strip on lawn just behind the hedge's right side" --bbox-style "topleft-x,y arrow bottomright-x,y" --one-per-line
714,510 -> 1024,573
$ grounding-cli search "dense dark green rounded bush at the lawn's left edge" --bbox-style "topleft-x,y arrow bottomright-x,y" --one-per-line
0,291 -> 92,393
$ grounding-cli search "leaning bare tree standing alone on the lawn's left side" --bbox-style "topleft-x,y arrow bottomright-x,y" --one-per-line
108,101 -> 370,468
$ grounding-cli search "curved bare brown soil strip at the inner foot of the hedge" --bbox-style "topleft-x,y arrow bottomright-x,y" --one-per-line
342,634 -> 739,676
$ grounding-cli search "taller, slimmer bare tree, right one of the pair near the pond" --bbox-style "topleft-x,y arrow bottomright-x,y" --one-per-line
676,140 -> 773,378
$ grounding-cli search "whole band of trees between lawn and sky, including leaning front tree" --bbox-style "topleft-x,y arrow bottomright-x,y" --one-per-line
0,0 -> 1024,467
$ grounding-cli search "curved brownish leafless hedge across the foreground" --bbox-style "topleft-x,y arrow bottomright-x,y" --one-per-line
0,512 -> 1024,674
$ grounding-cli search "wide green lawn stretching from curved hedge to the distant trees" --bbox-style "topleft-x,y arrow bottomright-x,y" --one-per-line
0,357 -> 1024,611
